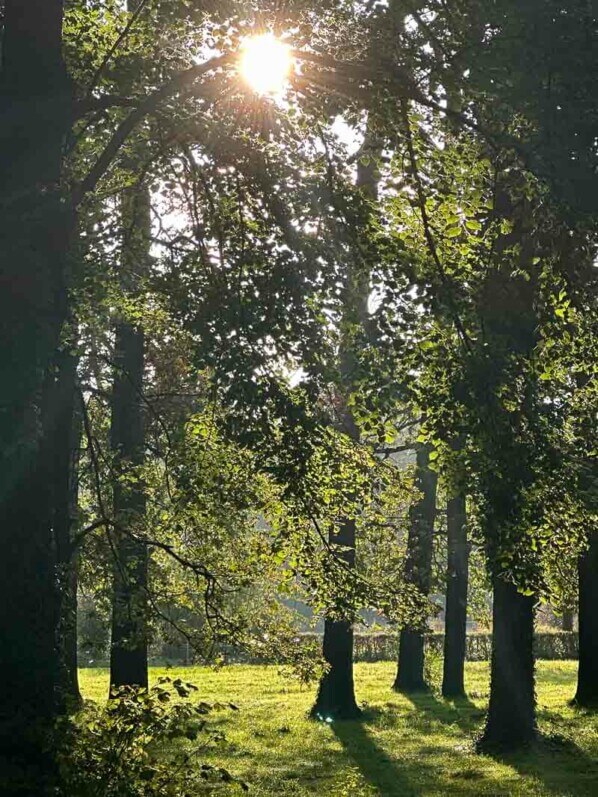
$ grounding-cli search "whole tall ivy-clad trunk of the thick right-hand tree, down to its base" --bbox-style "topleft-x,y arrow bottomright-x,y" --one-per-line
474,183 -> 544,751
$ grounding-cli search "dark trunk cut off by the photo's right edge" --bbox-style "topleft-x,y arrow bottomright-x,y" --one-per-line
575,531 -> 598,709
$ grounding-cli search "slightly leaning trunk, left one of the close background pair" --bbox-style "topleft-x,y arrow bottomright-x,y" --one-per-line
393,445 -> 438,692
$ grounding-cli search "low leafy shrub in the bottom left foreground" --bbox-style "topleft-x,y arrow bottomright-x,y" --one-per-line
58,678 -> 247,797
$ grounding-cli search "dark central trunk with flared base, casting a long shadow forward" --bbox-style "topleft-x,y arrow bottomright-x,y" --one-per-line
311,520 -> 361,720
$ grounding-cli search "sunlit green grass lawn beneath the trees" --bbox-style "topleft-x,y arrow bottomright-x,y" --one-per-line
81,661 -> 598,797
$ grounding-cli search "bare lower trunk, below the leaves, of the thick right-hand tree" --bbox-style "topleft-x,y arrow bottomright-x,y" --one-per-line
479,577 -> 536,750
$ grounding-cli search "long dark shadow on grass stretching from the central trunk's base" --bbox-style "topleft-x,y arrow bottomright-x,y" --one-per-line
331,721 -> 429,797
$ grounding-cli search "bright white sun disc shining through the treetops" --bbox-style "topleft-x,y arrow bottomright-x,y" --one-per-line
239,33 -> 293,95
